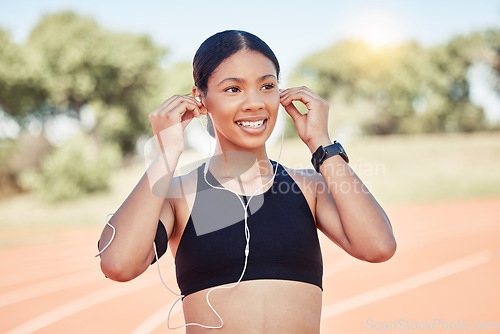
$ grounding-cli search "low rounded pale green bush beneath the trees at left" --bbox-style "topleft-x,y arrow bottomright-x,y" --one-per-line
21,135 -> 120,202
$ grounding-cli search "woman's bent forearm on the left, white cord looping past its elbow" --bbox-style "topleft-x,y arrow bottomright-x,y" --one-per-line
99,153 -> 179,281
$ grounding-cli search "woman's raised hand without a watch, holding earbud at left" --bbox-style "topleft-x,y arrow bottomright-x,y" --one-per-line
149,95 -> 207,153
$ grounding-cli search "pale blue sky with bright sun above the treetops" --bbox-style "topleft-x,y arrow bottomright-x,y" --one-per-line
0,0 -> 500,77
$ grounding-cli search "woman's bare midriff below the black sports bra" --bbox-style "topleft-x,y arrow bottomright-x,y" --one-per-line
183,279 -> 322,334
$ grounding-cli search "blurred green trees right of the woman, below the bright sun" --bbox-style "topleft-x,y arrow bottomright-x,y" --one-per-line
291,31 -> 500,134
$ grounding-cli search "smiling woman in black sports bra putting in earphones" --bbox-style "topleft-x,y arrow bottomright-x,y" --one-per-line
96,30 -> 396,333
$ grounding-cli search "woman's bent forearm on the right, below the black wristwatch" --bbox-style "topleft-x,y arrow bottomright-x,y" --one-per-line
310,140 -> 396,262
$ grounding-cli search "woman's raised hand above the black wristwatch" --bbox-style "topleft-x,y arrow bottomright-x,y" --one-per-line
280,86 -> 331,152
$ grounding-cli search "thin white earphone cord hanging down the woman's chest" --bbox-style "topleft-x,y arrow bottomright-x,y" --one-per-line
96,103 -> 286,329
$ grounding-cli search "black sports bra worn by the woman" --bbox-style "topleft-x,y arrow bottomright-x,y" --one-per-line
155,162 -> 323,296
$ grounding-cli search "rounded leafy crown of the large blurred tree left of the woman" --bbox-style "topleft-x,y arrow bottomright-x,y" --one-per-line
23,12 -> 166,152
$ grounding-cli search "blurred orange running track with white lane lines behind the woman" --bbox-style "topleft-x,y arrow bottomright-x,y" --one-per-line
0,198 -> 500,334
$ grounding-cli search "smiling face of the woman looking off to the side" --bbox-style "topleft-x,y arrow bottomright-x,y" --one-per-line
202,51 -> 280,150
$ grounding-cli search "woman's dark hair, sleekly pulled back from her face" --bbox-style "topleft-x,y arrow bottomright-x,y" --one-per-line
193,30 -> 280,94
